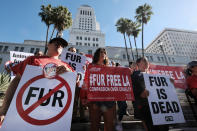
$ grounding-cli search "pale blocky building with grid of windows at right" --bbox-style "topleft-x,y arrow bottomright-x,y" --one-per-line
146,28 -> 197,60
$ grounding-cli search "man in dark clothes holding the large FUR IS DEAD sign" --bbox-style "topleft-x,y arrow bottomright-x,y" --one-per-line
131,57 -> 168,131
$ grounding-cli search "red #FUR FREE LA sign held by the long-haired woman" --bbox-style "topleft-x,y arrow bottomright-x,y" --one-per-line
85,65 -> 134,101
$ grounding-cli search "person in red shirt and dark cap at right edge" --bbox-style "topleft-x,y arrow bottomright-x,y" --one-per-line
187,61 -> 197,98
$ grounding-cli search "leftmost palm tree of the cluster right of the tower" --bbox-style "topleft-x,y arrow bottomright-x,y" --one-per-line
115,18 -> 130,63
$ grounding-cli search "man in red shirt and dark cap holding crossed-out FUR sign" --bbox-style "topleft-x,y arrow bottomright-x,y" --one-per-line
0,38 -> 73,121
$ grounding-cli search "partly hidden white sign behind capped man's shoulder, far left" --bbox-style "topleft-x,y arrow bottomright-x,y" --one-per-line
10,51 -> 34,63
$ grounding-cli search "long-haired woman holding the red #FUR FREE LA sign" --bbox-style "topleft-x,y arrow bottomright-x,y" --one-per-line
80,48 -> 116,131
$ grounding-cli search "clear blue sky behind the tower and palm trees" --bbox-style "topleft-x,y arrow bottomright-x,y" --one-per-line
0,0 -> 197,47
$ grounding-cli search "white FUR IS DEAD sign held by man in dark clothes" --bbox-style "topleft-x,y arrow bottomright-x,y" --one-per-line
144,74 -> 185,125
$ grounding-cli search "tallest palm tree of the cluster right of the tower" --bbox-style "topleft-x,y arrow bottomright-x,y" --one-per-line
135,4 -> 153,57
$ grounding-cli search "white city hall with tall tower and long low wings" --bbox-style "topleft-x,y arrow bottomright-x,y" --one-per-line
0,5 -> 192,72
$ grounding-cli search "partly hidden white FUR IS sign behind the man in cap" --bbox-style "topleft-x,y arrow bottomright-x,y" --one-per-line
61,49 -> 86,73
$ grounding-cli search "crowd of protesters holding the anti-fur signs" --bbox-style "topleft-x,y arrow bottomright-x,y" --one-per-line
0,38 -> 197,131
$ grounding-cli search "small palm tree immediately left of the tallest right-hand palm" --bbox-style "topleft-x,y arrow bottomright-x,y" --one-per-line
132,22 -> 141,59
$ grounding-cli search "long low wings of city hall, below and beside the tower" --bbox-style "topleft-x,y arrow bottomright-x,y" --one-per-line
0,40 -> 190,72
